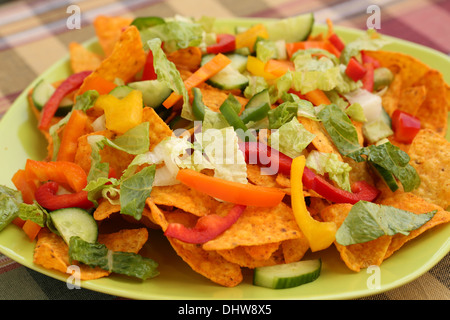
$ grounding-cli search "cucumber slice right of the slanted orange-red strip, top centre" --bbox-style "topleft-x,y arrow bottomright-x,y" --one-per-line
201,54 -> 248,90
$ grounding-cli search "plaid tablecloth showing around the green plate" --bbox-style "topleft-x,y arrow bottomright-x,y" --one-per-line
0,0 -> 450,300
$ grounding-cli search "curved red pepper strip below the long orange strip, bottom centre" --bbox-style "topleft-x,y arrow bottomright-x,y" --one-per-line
164,205 -> 246,244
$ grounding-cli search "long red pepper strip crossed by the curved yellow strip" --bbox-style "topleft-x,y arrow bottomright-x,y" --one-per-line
239,142 -> 380,204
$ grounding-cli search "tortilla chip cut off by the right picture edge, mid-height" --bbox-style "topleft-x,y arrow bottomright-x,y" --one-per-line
409,129 -> 450,208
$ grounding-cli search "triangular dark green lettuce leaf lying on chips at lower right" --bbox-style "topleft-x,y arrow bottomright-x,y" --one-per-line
336,201 -> 437,246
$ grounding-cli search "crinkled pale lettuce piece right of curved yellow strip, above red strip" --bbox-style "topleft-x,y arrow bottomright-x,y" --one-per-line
306,150 -> 352,192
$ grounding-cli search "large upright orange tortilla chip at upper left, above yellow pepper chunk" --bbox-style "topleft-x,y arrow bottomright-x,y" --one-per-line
77,26 -> 146,95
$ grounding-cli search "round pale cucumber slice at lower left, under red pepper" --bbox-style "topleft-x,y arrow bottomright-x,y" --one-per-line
50,208 -> 98,244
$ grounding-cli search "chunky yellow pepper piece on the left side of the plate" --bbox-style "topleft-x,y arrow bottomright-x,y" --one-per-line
95,90 -> 144,134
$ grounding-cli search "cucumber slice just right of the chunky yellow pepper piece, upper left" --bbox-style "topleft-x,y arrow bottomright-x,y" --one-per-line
128,80 -> 172,108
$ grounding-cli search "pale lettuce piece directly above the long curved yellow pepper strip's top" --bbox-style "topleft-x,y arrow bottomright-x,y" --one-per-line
270,117 -> 315,158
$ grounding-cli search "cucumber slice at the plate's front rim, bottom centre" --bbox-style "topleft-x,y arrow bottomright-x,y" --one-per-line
253,259 -> 322,289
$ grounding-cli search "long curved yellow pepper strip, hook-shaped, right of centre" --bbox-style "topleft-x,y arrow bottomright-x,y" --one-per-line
291,156 -> 337,252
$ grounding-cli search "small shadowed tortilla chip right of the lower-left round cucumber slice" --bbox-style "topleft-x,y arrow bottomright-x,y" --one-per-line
98,228 -> 148,253
